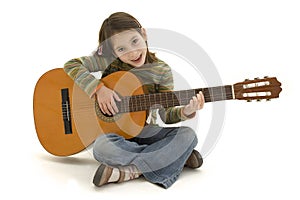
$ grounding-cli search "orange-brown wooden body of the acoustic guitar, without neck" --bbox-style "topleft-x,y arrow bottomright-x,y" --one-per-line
33,68 -> 146,156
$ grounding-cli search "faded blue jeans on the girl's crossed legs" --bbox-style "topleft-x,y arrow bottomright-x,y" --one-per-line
93,125 -> 198,188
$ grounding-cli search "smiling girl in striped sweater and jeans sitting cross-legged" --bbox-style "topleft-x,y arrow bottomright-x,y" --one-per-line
64,12 -> 204,188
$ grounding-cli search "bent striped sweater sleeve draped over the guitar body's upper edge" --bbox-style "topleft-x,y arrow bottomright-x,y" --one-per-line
64,55 -> 107,97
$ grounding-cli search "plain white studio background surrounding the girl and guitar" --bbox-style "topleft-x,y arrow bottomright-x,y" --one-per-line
0,0 -> 300,199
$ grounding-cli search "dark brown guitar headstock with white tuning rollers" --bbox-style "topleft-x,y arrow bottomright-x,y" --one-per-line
233,77 -> 282,101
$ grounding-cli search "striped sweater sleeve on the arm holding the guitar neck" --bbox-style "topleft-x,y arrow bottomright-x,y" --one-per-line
159,65 -> 195,124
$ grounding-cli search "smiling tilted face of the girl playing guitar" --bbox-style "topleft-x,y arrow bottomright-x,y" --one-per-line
111,29 -> 147,67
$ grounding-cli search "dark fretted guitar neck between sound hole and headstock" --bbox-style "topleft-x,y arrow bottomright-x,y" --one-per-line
117,85 -> 234,113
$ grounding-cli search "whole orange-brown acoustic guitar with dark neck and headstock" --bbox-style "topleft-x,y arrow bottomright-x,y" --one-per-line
33,68 -> 282,156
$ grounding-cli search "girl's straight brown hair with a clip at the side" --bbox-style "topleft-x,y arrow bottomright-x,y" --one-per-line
98,12 -> 158,63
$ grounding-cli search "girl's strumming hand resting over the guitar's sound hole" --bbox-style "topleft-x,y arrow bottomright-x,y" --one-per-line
96,85 -> 121,115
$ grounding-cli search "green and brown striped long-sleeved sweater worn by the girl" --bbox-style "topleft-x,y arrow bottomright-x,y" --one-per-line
64,54 -> 192,124
